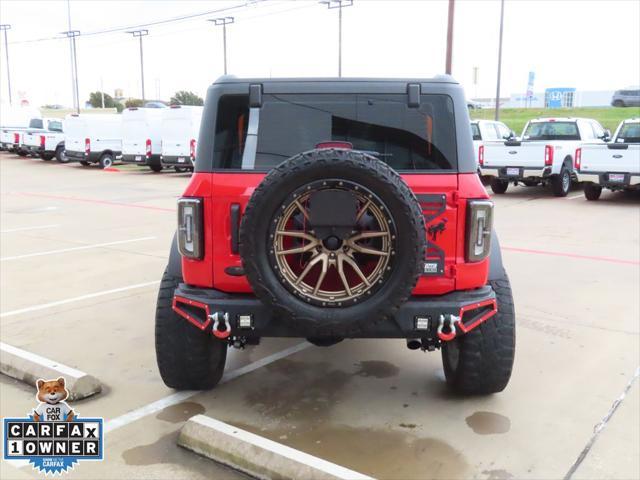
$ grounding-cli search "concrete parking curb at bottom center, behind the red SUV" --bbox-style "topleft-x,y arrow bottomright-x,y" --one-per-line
178,415 -> 373,480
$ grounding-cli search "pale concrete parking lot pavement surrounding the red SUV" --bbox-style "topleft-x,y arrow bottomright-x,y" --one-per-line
0,153 -> 640,480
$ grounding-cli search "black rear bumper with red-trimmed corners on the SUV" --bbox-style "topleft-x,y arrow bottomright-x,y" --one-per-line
173,284 -> 496,339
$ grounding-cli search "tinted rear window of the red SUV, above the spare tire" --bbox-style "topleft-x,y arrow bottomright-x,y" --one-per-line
214,94 -> 457,171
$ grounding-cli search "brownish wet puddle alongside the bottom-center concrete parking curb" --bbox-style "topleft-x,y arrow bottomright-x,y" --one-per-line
233,422 -> 470,480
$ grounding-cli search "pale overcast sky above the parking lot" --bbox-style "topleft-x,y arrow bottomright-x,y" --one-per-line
0,0 -> 640,105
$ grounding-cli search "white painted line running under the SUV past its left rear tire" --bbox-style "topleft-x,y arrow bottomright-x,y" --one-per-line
104,342 -> 311,432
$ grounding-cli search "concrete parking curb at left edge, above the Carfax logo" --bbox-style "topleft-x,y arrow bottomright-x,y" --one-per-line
0,342 -> 102,401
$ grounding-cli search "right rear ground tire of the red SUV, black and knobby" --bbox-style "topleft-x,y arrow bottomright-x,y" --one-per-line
442,275 -> 516,395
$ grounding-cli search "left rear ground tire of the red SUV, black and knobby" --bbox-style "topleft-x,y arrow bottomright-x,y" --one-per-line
156,270 -> 228,390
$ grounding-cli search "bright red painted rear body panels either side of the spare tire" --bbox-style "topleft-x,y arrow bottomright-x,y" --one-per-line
182,172 -> 489,295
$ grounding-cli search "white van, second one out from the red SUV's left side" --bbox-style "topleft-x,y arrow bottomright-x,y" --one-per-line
122,107 -> 165,172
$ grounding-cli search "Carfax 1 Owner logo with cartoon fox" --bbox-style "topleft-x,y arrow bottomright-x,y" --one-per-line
3,377 -> 104,474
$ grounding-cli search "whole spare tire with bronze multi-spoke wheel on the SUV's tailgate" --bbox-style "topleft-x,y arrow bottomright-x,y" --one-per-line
240,149 -> 426,336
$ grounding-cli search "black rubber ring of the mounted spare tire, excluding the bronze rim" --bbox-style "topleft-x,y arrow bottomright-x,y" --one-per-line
240,149 -> 426,337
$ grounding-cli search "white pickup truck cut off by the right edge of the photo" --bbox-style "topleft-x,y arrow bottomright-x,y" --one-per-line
574,118 -> 640,200
